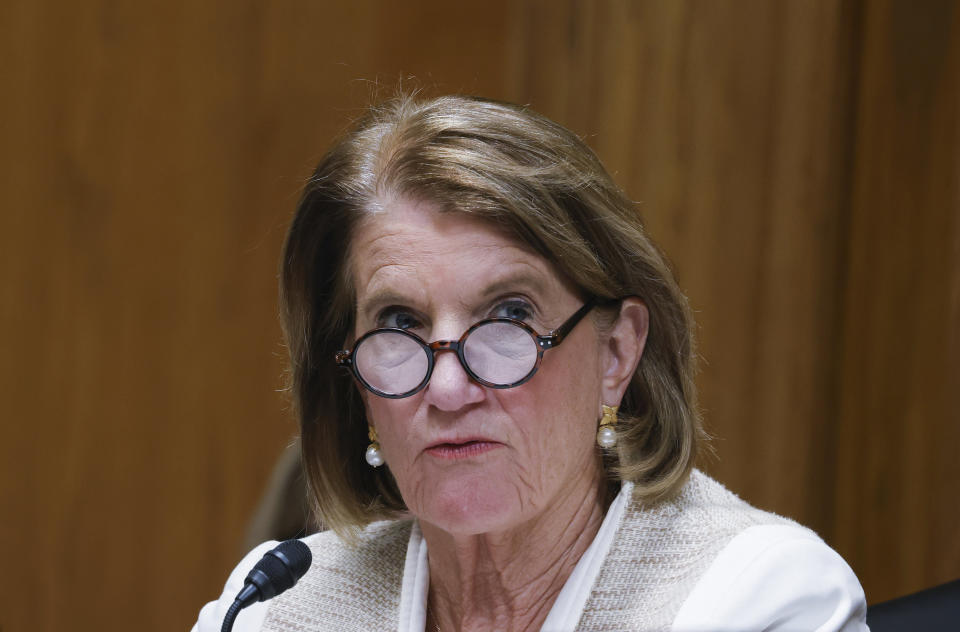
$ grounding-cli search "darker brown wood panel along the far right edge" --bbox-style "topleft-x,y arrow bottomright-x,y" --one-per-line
835,0 -> 960,599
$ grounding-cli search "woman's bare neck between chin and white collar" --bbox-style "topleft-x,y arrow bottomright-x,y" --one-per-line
420,472 -> 607,631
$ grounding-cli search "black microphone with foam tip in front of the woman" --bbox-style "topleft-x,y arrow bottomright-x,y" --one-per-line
220,539 -> 313,632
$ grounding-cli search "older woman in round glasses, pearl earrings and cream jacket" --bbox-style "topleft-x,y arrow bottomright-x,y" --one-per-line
195,97 -> 866,632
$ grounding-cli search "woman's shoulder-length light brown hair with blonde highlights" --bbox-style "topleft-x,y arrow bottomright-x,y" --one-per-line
280,95 -> 705,536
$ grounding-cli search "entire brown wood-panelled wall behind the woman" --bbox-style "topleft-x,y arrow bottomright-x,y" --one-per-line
0,0 -> 960,632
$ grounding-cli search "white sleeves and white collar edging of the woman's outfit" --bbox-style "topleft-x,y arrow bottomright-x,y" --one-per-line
192,482 -> 868,632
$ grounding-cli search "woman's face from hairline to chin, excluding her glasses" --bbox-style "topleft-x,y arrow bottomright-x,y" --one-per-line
351,201 -> 603,535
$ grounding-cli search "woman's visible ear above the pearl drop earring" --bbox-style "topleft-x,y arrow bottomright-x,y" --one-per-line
601,296 -> 650,406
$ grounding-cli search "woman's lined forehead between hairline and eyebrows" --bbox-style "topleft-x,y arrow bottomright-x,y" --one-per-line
349,200 -> 562,305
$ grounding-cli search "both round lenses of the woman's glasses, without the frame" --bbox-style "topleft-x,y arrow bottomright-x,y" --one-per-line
353,322 -> 538,395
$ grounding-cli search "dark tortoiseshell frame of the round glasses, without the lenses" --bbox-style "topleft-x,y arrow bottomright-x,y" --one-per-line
334,299 -> 598,399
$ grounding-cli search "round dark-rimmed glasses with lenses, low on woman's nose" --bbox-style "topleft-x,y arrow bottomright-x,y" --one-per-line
335,300 -> 596,399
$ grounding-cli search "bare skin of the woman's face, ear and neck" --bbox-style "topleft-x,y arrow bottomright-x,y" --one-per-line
350,199 -> 647,629
